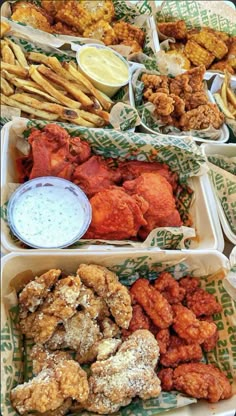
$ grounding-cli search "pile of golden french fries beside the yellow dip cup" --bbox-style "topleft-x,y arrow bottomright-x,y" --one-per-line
1,22 -> 113,127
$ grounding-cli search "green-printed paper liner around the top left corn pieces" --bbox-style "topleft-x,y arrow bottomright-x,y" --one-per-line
2,0 -> 155,55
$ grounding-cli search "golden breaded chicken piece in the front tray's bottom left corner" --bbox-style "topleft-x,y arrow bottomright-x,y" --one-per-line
11,360 -> 89,414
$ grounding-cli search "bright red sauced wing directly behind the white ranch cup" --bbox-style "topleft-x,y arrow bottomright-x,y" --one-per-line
29,124 -> 91,179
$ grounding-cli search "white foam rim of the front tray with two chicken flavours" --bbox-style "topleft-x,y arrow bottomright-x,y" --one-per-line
1,250 -> 235,416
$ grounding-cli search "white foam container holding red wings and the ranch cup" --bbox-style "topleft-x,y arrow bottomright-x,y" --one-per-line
1,119 -> 224,252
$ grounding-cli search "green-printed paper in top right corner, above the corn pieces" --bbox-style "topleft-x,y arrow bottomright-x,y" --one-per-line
156,0 -> 236,36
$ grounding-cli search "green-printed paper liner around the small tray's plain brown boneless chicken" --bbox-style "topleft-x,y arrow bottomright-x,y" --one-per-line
132,67 -> 221,140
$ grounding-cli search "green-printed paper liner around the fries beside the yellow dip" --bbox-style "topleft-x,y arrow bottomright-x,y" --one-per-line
0,18 -> 140,131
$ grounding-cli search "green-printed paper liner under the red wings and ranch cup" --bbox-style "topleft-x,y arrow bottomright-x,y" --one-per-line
1,115 -> 208,249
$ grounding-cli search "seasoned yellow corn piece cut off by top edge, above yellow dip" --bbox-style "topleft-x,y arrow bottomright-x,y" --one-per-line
55,0 -> 114,34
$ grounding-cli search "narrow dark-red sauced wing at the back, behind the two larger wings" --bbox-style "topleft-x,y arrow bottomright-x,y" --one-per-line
118,160 -> 178,191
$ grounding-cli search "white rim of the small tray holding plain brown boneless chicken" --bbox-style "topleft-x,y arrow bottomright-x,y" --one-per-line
129,77 -> 229,143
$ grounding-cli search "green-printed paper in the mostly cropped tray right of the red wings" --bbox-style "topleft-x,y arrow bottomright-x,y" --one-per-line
208,154 -> 236,236
